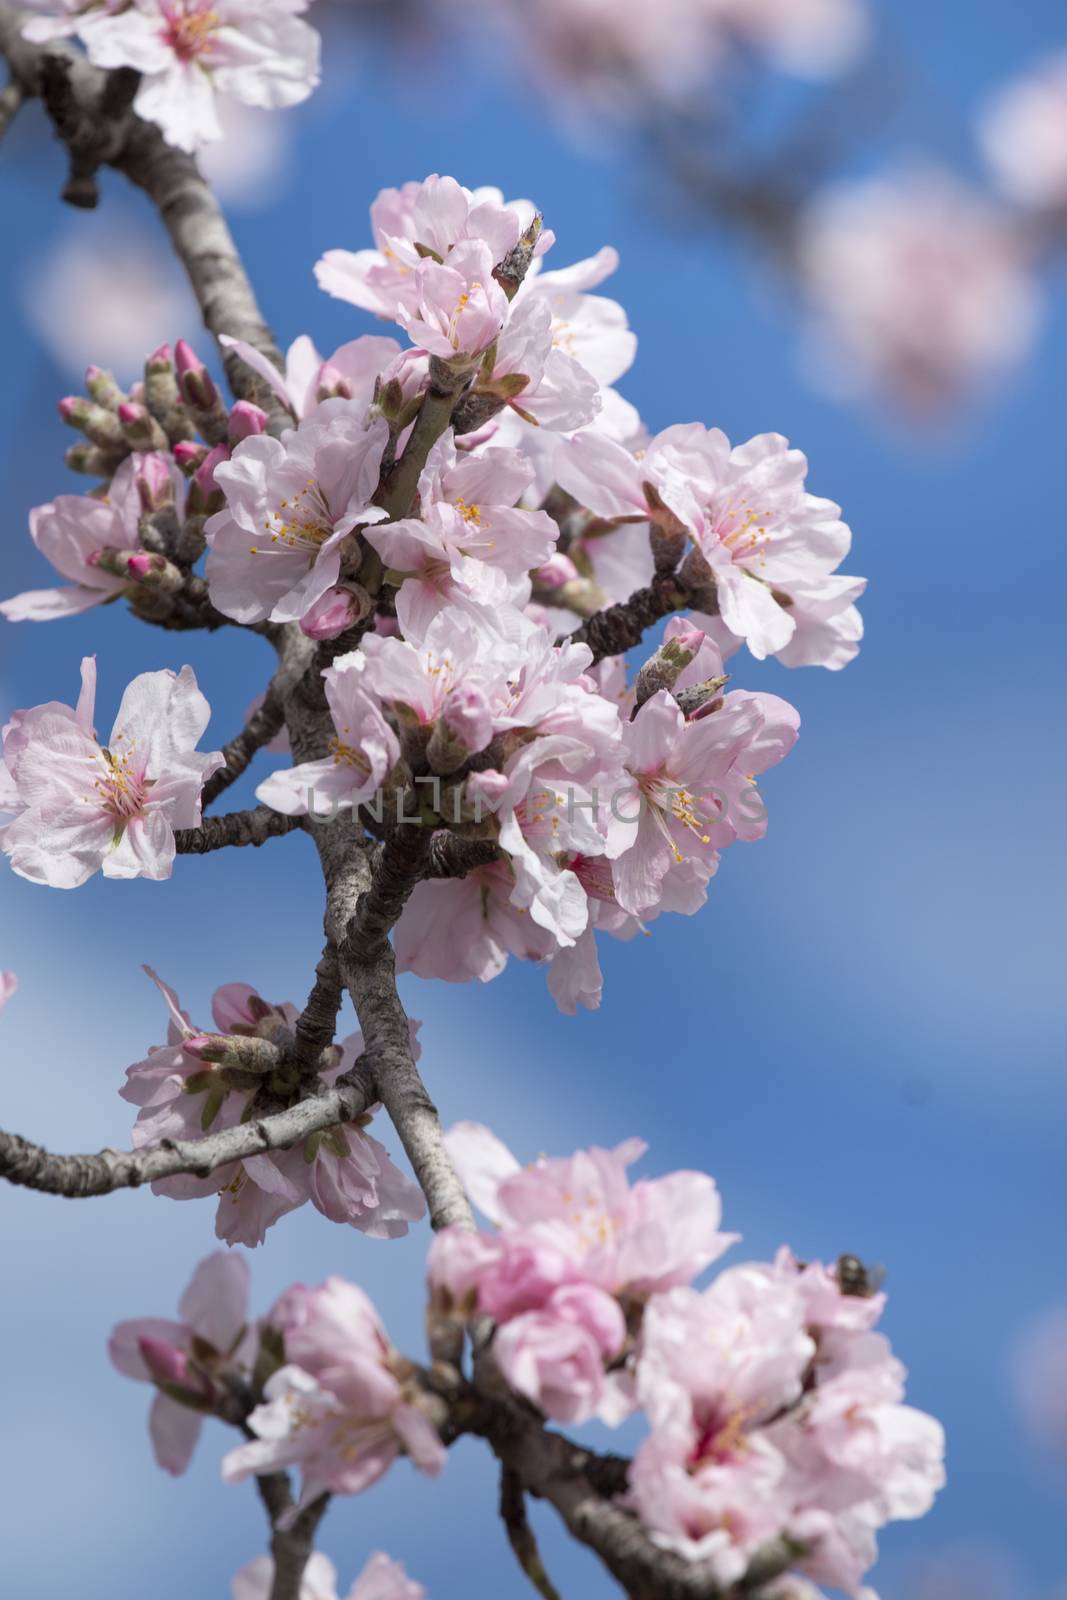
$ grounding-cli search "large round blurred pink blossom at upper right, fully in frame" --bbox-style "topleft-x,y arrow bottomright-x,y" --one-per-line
797,168 -> 1040,414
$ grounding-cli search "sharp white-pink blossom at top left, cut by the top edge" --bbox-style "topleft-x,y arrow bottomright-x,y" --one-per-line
21,0 -> 320,150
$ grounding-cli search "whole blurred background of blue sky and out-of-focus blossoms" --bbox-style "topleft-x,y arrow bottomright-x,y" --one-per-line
0,0 -> 1067,1600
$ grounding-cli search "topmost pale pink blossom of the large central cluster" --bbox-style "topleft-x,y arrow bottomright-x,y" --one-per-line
315,173 -> 550,318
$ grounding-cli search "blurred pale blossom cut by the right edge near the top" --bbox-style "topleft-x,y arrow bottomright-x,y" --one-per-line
981,51 -> 1067,208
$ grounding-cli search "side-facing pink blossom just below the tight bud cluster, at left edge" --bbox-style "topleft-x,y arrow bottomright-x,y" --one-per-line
0,454 -> 181,622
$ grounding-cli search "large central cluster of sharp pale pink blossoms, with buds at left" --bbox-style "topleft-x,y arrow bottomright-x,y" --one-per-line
5,176 -> 864,1011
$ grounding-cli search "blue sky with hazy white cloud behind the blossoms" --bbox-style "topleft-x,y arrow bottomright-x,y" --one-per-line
0,0 -> 1067,1600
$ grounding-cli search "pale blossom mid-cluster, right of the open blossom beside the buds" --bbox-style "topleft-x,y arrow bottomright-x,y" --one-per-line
366,430 -> 558,638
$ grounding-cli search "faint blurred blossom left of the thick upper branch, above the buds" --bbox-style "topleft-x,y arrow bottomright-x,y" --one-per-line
21,224 -> 200,381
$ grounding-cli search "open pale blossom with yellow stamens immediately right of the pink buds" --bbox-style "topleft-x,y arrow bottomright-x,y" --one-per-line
205,400 -> 389,622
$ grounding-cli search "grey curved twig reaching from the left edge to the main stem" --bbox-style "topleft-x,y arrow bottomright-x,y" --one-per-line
0,1064 -> 376,1200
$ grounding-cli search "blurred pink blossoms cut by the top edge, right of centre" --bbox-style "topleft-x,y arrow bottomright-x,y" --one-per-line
460,0 -> 869,120
